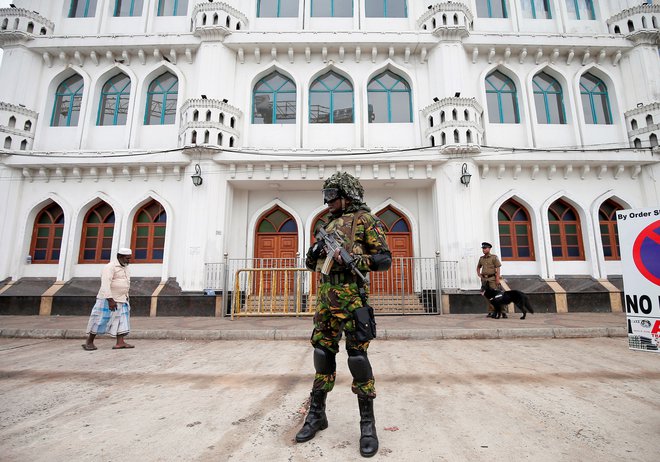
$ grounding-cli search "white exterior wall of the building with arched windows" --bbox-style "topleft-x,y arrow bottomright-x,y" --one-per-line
0,0 -> 660,290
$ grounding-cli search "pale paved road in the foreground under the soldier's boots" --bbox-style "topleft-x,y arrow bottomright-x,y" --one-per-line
0,338 -> 660,462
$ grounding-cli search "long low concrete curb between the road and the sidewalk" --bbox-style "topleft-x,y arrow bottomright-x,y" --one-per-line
0,326 -> 628,341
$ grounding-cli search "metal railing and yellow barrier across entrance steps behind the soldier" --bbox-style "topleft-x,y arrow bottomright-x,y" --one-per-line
205,257 -> 458,316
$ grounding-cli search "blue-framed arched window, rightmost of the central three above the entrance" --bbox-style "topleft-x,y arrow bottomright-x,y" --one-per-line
367,71 -> 412,123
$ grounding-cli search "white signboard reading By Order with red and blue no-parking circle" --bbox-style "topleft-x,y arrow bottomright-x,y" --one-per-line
616,207 -> 660,352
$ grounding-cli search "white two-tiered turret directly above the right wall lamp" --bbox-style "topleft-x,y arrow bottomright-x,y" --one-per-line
422,97 -> 484,152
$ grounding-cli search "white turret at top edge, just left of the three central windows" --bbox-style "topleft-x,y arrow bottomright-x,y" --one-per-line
192,2 -> 248,40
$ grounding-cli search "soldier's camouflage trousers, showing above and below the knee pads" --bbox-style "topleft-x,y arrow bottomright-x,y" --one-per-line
310,283 -> 376,398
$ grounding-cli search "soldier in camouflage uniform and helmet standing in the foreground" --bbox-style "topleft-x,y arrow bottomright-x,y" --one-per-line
296,173 -> 392,457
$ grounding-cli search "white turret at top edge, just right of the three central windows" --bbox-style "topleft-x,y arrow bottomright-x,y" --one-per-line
417,2 -> 473,40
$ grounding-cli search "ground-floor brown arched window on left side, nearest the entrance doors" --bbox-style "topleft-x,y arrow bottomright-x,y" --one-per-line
131,200 -> 167,263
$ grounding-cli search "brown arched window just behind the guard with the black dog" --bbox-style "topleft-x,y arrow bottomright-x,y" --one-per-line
497,199 -> 534,260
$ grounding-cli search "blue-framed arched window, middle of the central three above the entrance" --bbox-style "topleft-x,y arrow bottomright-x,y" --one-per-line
309,71 -> 353,124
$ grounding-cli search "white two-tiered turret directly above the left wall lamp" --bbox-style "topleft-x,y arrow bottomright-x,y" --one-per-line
179,98 -> 243,148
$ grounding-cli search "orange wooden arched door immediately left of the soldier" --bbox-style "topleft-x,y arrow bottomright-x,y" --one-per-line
254,206 -> 298,295
